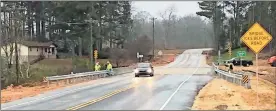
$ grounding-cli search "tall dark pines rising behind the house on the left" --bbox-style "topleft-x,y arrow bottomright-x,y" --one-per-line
1,1 -> 132,55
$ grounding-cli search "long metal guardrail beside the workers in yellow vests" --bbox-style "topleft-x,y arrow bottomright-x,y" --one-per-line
44,67 -> 133,85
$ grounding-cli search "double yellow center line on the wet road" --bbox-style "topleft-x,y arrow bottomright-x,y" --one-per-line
66,76 -> 163,110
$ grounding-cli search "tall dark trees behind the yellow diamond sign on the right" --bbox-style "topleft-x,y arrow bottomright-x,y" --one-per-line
196,1 -> 276,52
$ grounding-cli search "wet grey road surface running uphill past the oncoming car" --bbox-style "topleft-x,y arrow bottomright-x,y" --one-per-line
1,49 -> 212,110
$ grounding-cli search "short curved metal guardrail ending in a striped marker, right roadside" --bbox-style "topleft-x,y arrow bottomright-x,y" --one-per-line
212,63 -> 252,89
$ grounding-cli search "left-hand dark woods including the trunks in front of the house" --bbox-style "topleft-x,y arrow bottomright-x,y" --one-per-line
0,1 -> 132,84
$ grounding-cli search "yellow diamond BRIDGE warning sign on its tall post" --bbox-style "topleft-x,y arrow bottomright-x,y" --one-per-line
241,22 -> 272,109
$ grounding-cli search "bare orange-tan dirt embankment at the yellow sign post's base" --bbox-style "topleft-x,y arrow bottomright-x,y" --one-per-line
192,78 -> 276,110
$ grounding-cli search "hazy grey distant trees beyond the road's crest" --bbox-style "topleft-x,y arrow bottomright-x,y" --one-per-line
131,5 -> 215,49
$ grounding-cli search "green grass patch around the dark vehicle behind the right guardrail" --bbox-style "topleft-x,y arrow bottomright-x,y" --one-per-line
213,48 -> 255,61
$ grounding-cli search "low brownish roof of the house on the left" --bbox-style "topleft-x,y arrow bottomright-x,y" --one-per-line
21,41 -> 57,47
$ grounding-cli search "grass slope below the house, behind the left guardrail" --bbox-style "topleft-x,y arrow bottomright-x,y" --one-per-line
2,57 -> 132,87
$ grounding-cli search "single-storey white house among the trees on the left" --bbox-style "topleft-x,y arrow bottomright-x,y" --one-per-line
1,41 -> 57,64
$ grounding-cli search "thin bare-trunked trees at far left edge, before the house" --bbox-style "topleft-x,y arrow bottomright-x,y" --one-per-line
1,2 -> 28,84
